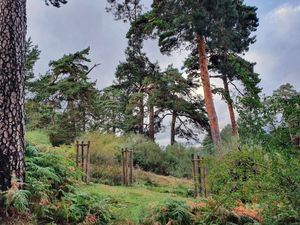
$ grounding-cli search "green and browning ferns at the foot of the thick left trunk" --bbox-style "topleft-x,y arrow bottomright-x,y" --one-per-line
2,146 -> 111,225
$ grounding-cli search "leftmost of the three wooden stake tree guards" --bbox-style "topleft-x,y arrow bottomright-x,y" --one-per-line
76,141 -> 91,184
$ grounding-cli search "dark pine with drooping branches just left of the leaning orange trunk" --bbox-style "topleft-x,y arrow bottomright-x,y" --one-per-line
150,66 -> 208,145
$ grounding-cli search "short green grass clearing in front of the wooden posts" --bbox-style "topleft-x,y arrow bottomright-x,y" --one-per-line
80,184 -> 192,224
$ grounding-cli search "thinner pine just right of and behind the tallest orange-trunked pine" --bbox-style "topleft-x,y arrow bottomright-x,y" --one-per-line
184,50 -> 261,136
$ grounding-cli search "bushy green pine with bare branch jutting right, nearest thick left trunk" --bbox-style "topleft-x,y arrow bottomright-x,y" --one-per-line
32,48 -> 98,143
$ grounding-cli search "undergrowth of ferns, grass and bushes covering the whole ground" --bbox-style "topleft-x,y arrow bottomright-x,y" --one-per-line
1,133 -> 300,225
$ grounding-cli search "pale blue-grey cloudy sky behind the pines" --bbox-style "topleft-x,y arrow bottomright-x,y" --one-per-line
28,0 -> 300,144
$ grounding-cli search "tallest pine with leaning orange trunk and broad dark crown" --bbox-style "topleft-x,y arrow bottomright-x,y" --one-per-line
129,0 -> 258,147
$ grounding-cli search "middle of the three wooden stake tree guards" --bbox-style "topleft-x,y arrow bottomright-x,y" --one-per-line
121,148 -> 133,186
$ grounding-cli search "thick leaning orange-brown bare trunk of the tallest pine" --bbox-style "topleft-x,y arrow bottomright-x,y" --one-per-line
197,36 -> 221,149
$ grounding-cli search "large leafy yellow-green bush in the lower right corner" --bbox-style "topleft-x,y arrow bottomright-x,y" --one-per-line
209,147 -> 300,224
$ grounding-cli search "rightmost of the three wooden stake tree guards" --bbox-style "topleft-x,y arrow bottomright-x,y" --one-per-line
192,154 -> 208,197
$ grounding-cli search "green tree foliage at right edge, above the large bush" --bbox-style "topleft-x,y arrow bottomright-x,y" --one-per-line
239,84 -> 300,155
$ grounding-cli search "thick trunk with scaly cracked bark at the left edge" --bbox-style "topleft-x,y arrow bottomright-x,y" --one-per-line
0,0 -> 26,191
